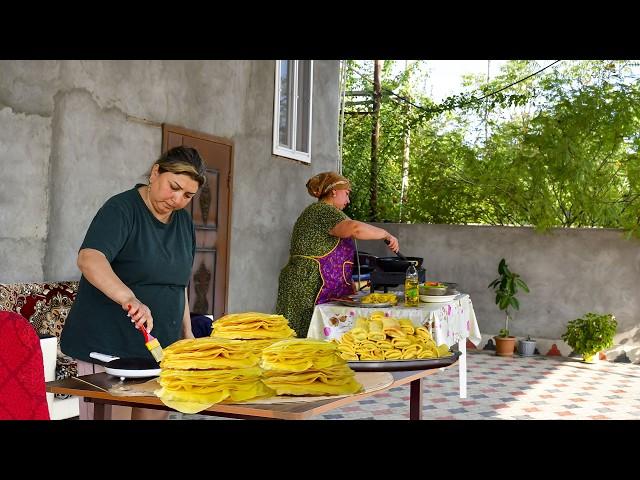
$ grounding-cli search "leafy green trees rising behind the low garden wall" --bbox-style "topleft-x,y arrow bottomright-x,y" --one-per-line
342,60 -> 640,237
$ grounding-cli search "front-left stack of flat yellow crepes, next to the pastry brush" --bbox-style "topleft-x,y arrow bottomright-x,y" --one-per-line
154,337 -> 273,413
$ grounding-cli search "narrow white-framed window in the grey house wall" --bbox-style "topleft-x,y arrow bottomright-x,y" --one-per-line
273,60 -> 313,163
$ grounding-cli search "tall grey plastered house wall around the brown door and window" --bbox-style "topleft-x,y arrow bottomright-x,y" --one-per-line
0,60 -> 339,311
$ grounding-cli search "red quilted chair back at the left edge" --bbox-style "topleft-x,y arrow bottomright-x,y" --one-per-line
0,311 -> 49,420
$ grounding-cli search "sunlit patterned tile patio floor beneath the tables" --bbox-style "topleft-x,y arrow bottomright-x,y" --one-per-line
170,351 -> 640,420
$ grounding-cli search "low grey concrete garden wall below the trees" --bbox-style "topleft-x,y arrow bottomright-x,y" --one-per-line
358,224 -> 640,346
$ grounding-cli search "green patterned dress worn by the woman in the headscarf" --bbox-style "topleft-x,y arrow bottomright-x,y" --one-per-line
276,202 -> 349,338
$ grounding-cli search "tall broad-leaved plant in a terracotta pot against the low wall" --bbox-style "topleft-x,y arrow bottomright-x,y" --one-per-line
489,258 -> 529,356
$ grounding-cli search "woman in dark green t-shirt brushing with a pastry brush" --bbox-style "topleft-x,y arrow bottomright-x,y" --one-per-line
60,147 -> 206,419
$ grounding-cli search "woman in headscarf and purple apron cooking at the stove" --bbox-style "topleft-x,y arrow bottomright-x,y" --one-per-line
276,172 -> 400,338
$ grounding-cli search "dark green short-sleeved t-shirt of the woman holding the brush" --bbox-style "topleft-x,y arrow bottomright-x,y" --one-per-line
60,185 -> 195,362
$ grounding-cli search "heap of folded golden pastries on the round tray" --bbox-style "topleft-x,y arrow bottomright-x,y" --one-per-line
335,312 -> 452,361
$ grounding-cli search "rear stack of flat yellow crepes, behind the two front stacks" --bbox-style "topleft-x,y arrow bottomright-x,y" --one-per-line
211,312 -> 295,339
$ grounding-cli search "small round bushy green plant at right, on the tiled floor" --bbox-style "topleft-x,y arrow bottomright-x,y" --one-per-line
561,312 -> 618,363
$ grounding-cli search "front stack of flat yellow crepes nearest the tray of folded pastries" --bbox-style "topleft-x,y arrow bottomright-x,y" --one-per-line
260,338 -> 362,395
